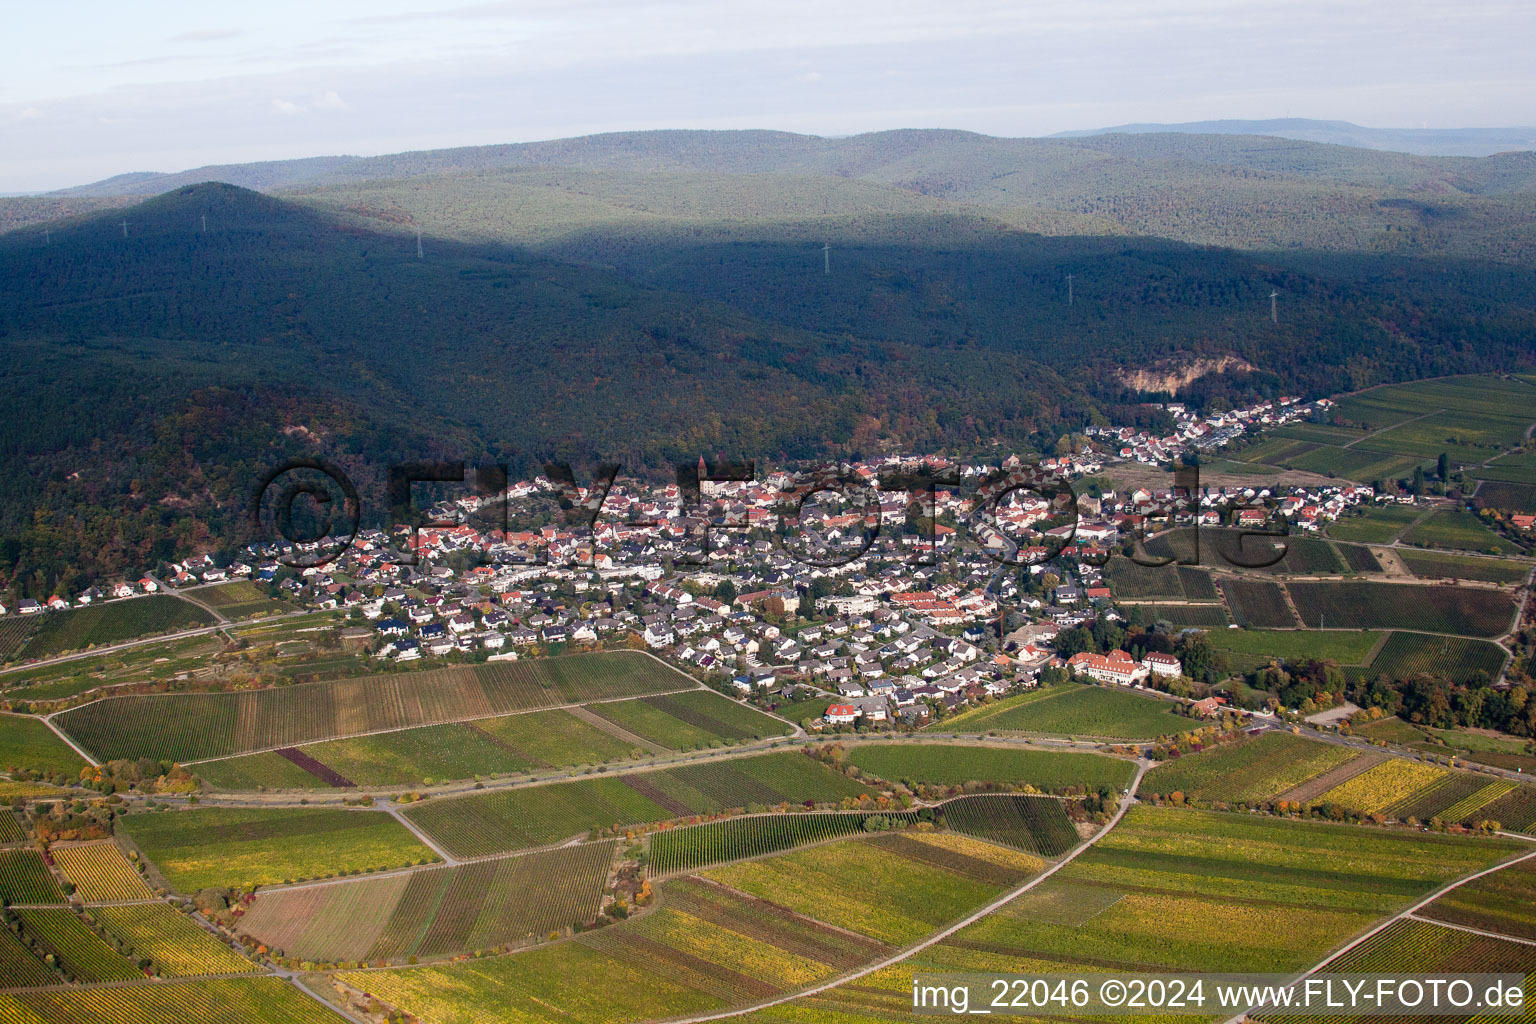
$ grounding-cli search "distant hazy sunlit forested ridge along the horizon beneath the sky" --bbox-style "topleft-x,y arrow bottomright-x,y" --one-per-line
24,129 -> 1536,266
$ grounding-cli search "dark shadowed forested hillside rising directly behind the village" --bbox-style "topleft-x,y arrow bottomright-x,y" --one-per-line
9,184 -> 1536,596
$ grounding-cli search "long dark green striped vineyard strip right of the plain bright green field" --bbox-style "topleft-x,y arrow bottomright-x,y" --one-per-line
406,752 -> 869,857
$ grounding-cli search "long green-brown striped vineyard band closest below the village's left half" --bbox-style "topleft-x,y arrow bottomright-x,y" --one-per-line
55,654 -> 697,761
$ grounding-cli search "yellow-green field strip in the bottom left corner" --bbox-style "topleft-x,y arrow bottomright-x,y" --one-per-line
0,978 -> 336,1024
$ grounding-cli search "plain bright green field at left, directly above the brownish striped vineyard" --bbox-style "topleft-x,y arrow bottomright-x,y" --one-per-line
120,808 -> 436,892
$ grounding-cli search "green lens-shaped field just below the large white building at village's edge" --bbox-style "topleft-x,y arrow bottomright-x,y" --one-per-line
928,683 -> 1189,740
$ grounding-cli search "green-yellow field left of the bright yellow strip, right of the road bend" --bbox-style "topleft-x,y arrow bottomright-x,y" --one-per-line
1141,732 -> 1356,803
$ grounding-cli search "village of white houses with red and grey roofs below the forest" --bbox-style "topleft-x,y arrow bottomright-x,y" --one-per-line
0,399 -> 1392,729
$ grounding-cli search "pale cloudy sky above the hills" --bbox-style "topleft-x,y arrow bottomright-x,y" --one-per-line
0,0 -> 1536,192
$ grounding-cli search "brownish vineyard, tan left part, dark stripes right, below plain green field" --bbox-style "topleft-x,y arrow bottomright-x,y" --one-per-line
240,841 -> 614,963
